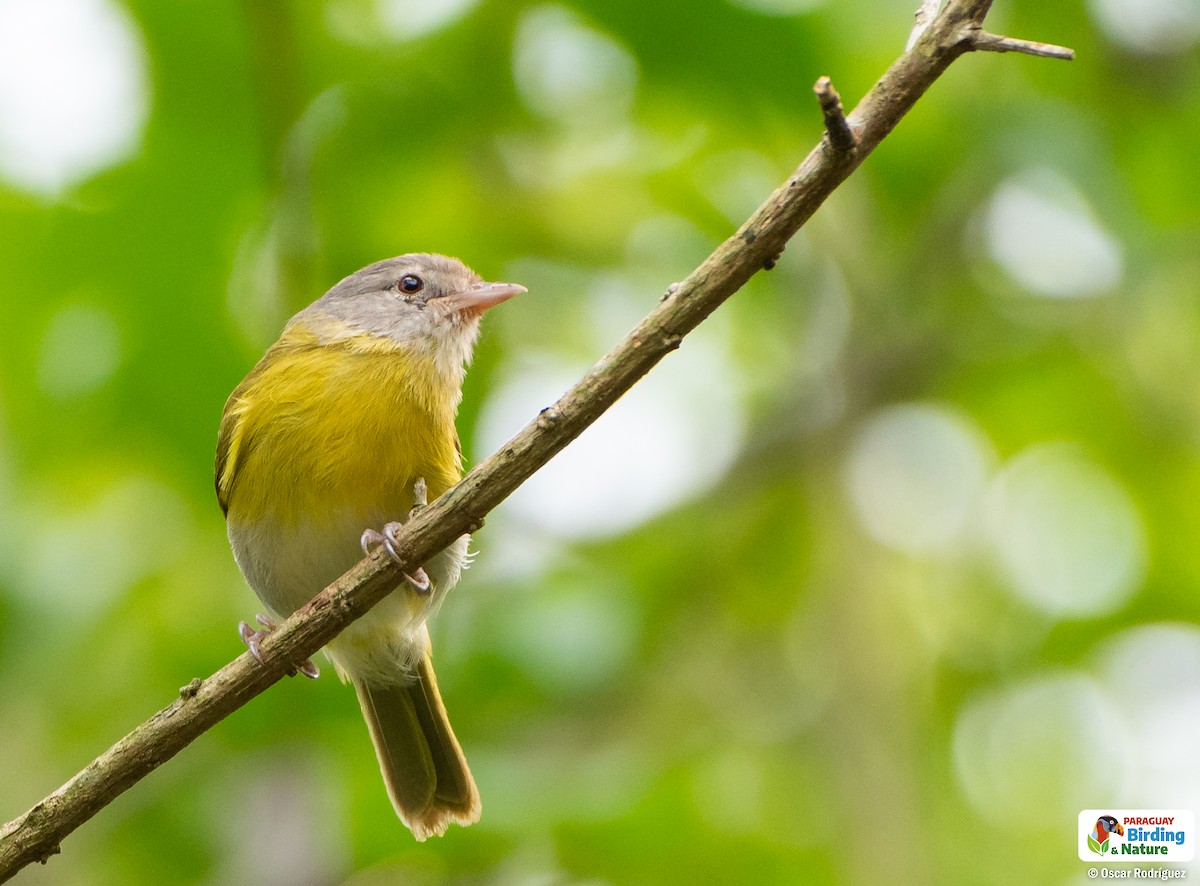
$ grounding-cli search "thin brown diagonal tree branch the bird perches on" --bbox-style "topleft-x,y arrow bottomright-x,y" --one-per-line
0,0 -> 1069,882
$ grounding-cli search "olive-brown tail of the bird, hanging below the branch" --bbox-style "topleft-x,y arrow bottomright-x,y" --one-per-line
354,652 -> 480,840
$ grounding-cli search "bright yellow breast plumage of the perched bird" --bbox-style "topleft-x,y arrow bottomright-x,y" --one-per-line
216,325 -> 462,528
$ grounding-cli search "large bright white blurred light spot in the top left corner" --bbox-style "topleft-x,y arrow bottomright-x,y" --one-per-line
0,0 -> 148,196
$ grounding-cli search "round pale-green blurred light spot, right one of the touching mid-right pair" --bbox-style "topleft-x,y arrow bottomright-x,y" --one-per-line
988,444 -> 1146,617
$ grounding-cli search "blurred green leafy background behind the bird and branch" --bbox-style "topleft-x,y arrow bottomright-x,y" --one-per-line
0,0 -> 1200,886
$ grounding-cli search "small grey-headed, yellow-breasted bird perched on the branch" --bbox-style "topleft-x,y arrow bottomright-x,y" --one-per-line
216,253 -> 526,840
